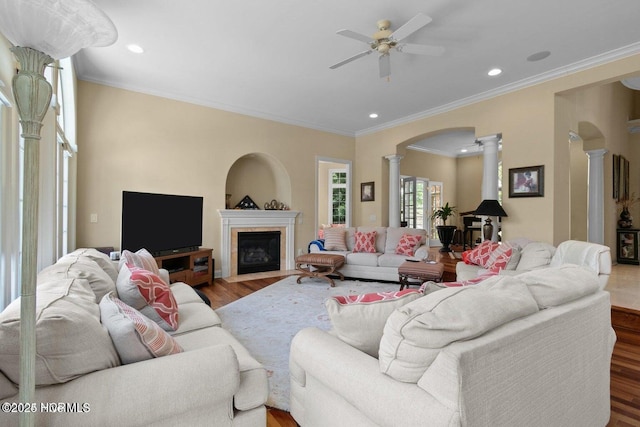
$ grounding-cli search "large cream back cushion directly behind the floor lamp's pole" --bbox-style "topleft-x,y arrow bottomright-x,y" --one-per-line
0,278 -> 120,385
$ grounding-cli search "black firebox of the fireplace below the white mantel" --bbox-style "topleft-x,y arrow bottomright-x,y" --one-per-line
237,231 -> 281,274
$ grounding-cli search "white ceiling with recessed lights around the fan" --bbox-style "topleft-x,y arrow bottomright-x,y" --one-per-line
75,0 -> 640,155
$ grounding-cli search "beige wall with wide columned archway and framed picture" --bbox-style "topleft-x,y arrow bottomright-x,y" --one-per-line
355,55 -> 640,245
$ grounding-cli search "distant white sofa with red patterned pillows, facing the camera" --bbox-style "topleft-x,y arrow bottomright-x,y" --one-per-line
309,227 -> 429,282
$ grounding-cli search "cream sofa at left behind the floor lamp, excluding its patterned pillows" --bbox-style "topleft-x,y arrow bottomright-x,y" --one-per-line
0,249 -> 268,426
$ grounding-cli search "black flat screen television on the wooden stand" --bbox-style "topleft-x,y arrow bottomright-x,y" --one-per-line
120,191 -> 203,256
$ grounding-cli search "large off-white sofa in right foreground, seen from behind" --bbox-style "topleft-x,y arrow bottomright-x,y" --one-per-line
290,242 -> 615,427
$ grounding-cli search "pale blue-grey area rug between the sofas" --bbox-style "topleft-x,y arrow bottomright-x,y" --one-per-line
216,276 -> 399,411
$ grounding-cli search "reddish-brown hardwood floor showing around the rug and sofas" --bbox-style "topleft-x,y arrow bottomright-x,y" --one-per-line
198,267 -> 640,427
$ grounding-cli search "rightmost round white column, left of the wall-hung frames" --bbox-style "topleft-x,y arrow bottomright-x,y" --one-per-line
586,148 -> 607,245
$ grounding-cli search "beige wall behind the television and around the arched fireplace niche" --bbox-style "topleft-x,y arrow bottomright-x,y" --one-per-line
77,81 -> 354,266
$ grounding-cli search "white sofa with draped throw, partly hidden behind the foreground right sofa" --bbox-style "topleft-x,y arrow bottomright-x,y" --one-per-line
456,238 -> 611,289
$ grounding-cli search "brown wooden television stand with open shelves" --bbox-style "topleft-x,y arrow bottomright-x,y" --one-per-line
155,248 -> 215,286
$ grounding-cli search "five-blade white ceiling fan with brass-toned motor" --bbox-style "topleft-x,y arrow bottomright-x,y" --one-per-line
329,13 -> 444,78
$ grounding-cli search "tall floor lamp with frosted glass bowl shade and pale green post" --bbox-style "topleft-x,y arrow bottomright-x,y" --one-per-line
0,0 -> 118,426
